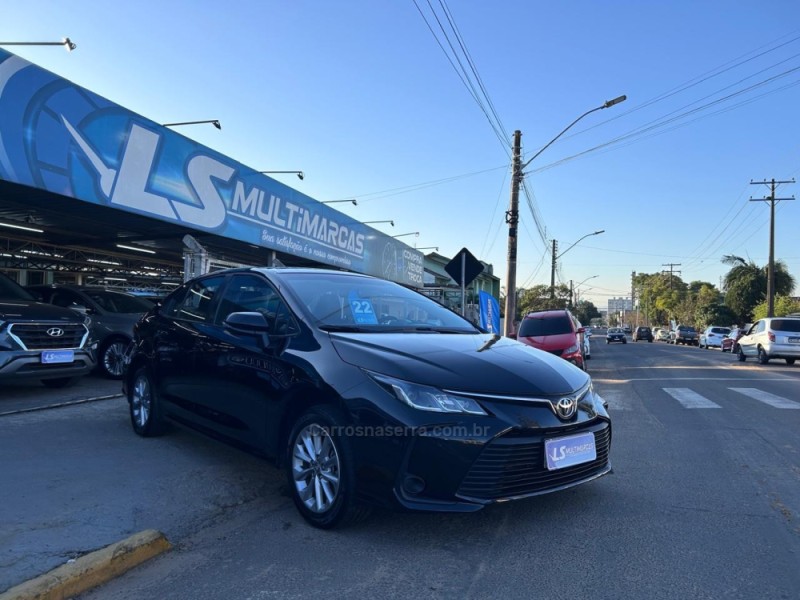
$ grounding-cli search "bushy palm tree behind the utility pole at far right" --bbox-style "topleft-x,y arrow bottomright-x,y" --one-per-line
722,255 -> 795,322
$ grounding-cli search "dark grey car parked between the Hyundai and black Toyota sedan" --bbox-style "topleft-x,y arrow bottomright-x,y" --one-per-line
26,284 -> 153,379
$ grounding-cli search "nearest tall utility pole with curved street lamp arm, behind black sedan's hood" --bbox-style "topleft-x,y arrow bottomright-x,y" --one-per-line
503,96 -> 627,335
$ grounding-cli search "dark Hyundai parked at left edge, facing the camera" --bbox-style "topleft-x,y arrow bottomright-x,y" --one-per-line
0,273 -> 95,388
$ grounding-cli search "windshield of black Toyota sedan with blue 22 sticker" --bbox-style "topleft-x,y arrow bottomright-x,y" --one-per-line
283,273 -> 480,333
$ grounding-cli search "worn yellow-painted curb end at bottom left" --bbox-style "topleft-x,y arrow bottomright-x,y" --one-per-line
0,529 -> 172,600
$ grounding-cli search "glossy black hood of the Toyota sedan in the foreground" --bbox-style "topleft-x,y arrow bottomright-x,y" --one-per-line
330,333 -> 589,396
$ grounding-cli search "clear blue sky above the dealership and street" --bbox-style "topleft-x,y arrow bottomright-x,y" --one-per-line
0,0 -> 800,308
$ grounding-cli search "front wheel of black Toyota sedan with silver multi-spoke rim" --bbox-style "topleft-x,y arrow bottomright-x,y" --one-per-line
286,405 -> 369,529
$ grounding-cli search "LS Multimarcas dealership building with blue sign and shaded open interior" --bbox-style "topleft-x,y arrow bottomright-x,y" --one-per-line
0,48 -> 499,305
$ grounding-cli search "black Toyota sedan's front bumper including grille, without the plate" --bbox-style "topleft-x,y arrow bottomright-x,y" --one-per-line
350,395 -> 612,512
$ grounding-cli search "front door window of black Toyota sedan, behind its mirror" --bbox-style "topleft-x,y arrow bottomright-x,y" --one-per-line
216,275 -> 297,335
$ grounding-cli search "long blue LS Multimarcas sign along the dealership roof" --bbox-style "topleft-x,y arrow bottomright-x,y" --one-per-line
0,49 -> 423,288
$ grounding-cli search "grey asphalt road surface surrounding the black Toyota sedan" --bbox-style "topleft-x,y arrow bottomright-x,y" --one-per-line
0,338 -> 800,600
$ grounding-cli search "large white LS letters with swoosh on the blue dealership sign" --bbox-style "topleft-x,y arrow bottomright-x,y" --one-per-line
61,115 -> 235,229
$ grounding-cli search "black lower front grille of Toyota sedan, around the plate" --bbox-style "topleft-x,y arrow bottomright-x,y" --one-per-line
457,423 -> 611,501
